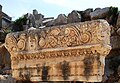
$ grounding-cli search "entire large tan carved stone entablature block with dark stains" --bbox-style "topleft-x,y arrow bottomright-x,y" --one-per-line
5,20 -> 111,82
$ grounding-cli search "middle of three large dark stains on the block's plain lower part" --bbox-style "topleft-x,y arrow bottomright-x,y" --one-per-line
61,61 -> 70,80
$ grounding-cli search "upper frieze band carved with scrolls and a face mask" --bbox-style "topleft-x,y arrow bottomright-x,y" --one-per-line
6,21 -> 110,51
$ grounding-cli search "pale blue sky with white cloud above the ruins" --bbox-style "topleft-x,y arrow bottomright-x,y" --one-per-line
0,0 -> 120,20
